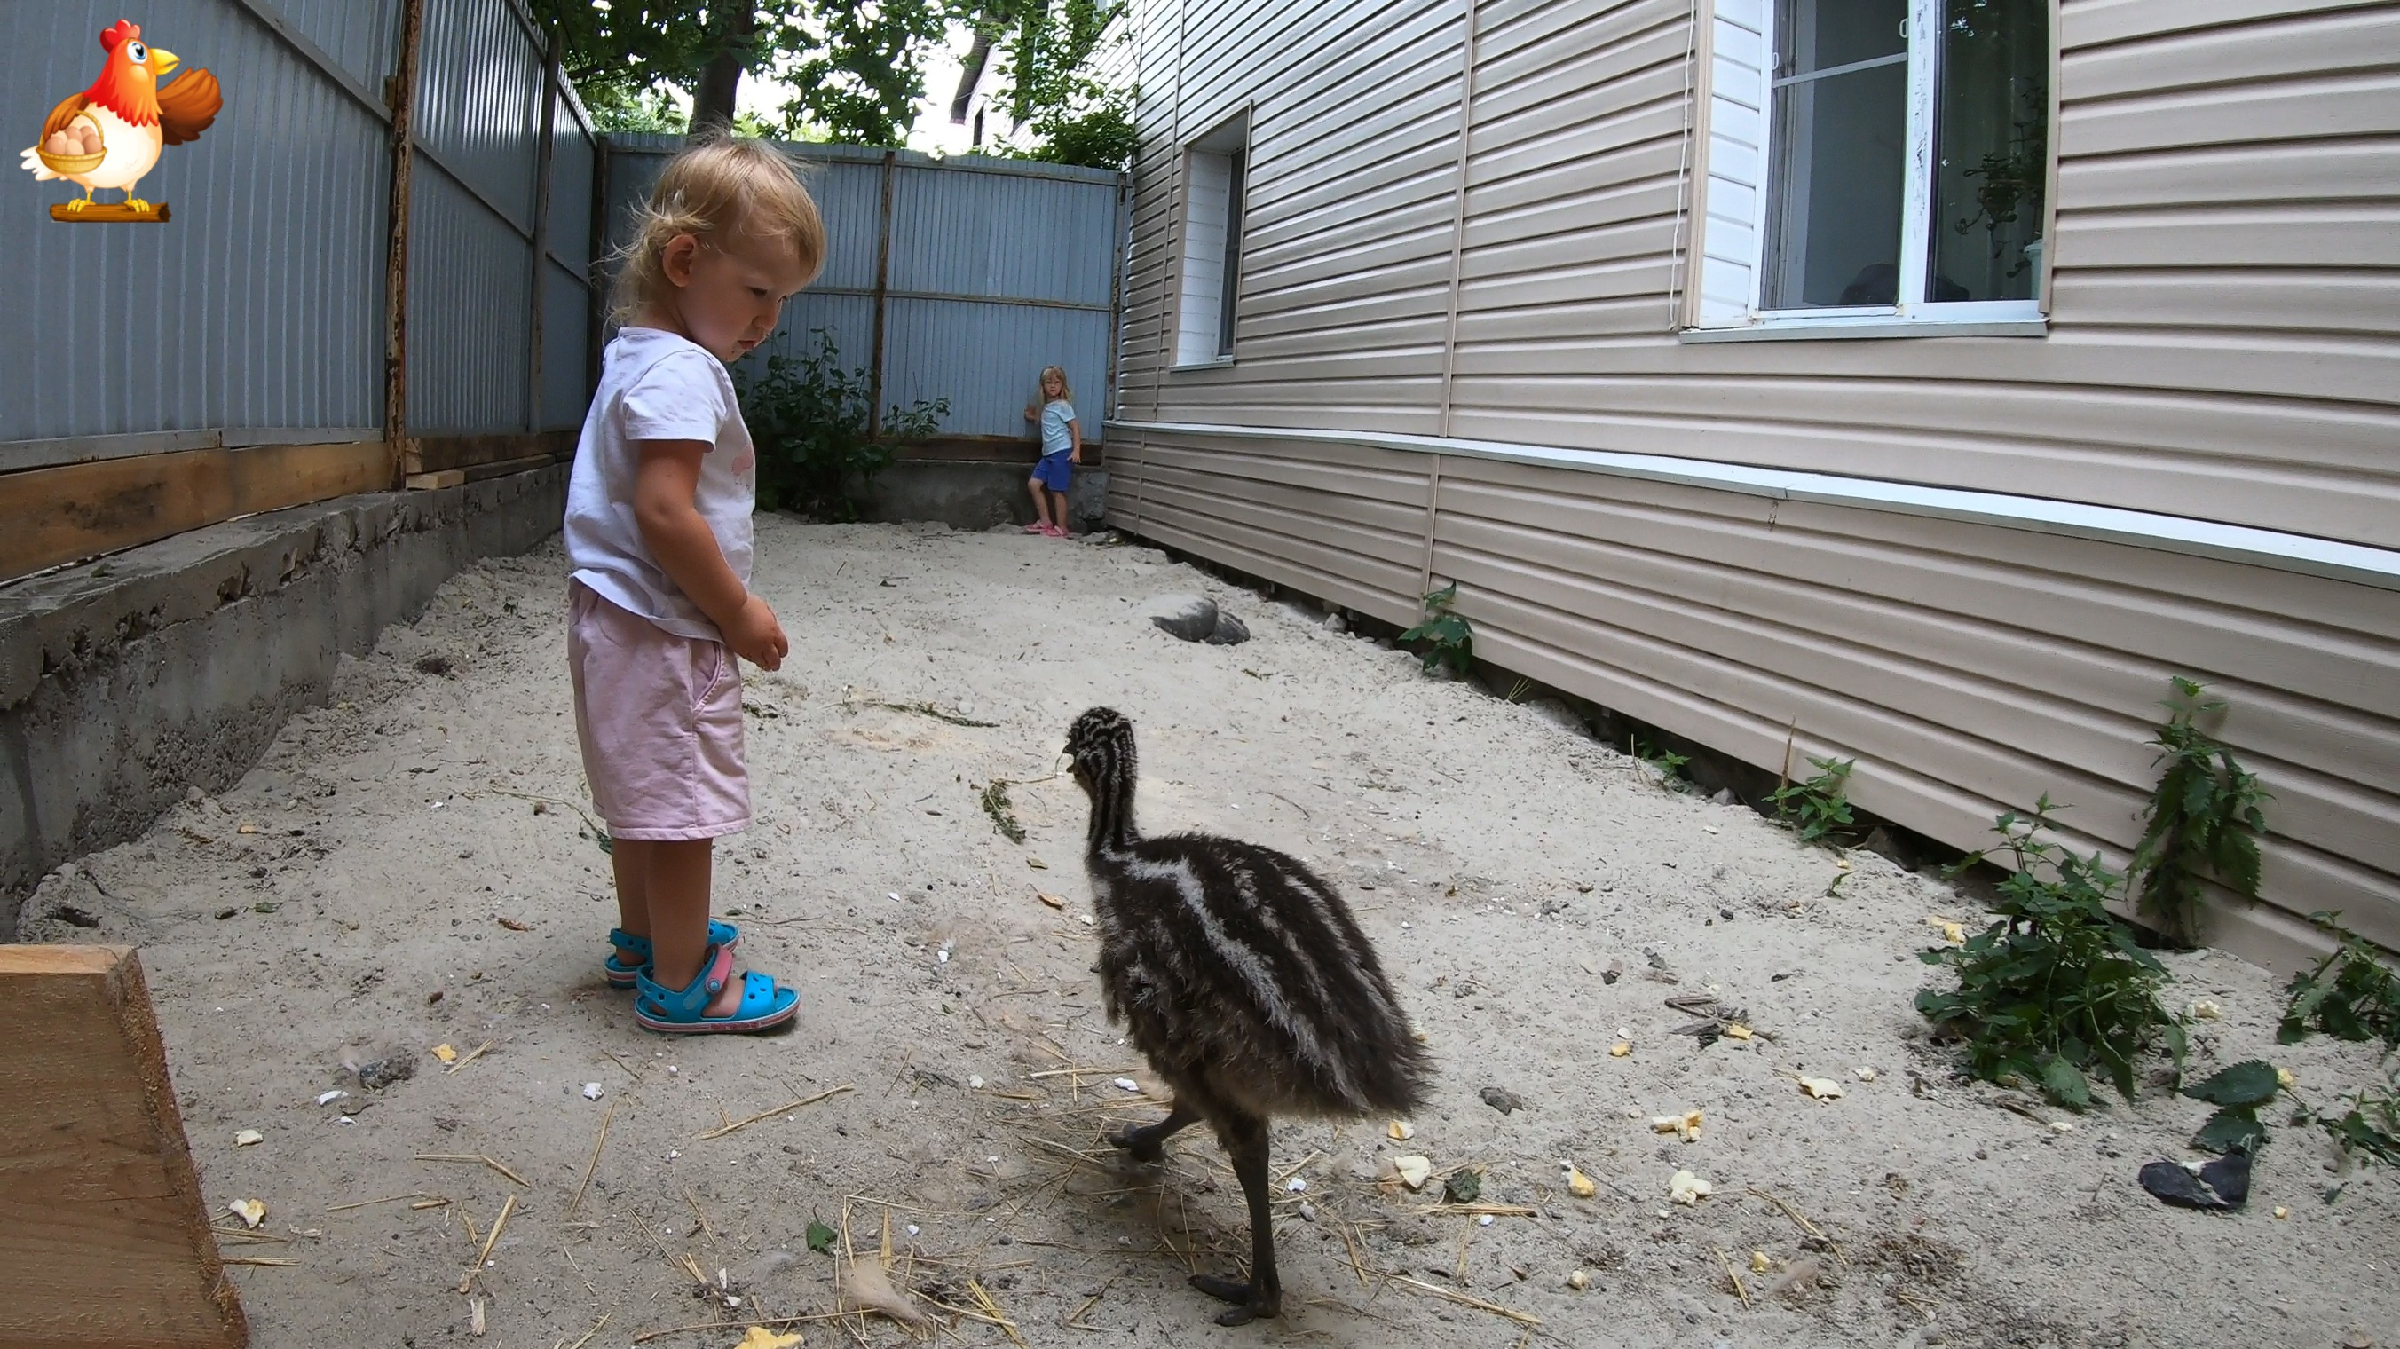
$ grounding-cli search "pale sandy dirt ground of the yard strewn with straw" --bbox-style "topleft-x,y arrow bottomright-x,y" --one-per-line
26,518 -> 2400,1349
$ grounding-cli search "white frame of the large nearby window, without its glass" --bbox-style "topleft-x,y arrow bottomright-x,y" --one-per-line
1680,0 -> 2059,341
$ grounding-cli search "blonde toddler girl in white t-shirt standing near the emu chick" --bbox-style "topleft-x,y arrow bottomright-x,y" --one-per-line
566,139 -> 826,1032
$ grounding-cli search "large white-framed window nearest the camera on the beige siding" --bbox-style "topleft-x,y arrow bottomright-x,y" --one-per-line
1697,0 -> 2052,336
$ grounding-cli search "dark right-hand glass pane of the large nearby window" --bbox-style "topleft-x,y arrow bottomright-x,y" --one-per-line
1925,0 -> 2050,305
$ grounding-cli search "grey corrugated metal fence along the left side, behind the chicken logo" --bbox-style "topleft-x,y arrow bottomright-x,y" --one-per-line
0,0 -> 598,473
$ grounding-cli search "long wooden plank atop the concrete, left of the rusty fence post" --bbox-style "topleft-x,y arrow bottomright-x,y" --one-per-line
0,442 -> 389,578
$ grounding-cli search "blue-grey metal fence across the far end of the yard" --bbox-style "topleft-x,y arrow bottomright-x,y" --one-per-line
605,134 -> 1128,439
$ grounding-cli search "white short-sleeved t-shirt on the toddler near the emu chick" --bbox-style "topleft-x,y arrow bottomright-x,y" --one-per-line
566,329 -> 758,641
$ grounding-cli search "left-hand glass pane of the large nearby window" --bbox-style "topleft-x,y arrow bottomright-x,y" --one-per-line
1762,0 -> 1900,310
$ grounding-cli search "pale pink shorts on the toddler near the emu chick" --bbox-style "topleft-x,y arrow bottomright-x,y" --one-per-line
566,581 -> 749,840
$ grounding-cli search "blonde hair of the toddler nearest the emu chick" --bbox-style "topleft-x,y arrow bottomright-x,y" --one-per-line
612,132 -> 826,324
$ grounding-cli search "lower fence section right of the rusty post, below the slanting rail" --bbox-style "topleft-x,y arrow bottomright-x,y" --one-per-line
408,161 -> 533,434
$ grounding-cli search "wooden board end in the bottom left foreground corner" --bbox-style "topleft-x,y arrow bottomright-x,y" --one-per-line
0,946 -> 250,1349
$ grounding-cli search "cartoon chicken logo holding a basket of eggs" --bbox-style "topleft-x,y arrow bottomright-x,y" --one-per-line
24,19 -> 226,221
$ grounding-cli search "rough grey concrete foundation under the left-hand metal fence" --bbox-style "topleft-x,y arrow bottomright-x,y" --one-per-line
0,466 -> 566,941
